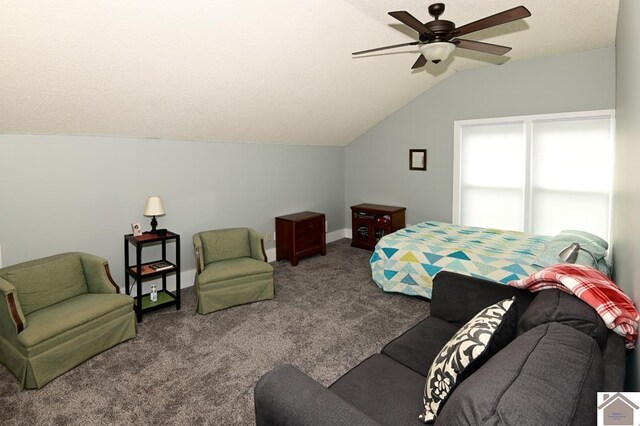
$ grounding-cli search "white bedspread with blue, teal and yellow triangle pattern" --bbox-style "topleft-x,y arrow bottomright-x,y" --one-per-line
369,221 -> 551,299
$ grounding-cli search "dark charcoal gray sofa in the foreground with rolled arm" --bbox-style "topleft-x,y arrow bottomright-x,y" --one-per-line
254,272 -> 626,426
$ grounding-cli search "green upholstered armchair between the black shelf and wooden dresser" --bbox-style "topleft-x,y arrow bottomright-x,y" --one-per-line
193,228 -> 274,314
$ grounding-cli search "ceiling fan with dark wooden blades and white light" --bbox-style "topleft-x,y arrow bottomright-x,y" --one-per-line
352,3 -> 531,69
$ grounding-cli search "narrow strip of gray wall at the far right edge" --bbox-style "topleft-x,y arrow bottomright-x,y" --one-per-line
613,0 -> 640,391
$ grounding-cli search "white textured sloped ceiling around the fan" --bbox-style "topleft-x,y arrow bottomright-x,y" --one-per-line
0,0 -> 618,145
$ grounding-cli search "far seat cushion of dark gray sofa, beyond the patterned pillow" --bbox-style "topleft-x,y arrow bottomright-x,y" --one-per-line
382,316 -> 460,377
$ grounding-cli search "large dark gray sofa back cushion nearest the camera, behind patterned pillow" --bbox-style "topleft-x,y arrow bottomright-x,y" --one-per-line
437,323 -> 603,426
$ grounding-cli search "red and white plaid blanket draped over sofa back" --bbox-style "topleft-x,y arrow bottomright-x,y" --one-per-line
509,263 -> 640,349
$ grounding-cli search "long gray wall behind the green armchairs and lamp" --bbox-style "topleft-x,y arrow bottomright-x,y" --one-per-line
0,135 -> 345,286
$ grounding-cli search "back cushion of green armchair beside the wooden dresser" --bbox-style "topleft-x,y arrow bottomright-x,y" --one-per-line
200,228 -> 251,265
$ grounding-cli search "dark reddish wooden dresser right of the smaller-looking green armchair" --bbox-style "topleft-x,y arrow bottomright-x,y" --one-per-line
276,212 -> 327,266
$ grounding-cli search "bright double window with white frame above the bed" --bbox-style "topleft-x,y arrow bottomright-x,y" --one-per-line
453,111 -> 614,240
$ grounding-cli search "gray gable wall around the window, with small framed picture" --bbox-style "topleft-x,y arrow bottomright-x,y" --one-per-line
345,48 -> 615,228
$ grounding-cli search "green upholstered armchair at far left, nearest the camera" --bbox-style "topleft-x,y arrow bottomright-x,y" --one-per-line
0,253 -> 136,389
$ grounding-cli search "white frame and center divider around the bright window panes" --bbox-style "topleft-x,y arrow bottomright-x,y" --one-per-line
452,109 -> 615,238
